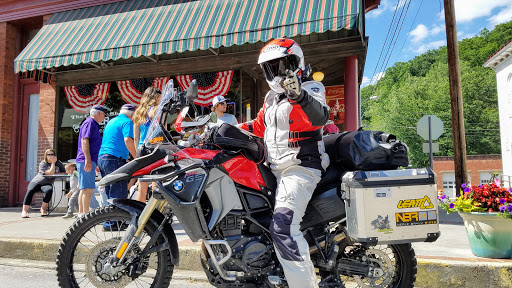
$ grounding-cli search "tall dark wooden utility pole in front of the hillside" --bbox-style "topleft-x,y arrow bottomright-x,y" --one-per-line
444,0 -> 468,196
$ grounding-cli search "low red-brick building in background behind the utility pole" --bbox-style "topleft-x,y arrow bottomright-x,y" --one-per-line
434,155 -> 503,197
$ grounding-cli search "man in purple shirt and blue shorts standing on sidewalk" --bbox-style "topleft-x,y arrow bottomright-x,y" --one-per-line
76,105 -> 107,216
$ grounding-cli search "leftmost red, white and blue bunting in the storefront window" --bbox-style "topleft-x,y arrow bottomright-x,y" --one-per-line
64,83 -> 110,113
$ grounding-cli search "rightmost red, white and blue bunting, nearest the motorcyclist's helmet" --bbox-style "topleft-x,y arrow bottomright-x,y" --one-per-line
176,70 -> 233,106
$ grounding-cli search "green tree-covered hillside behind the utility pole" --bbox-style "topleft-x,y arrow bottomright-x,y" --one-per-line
361,21 -> 512,167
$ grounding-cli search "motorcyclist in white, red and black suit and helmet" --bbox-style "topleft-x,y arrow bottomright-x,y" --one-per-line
241,39 -> 329,288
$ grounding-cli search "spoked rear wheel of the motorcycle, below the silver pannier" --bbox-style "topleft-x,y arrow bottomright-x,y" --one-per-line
322,244 -> 417,288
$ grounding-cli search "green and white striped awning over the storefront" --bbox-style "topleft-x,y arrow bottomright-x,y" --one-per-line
15,0 -> 362,73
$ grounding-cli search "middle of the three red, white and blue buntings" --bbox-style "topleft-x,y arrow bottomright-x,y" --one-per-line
117,77 -> 171,107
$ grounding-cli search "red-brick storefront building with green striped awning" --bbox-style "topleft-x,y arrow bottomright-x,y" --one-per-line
0,0 -> 380,207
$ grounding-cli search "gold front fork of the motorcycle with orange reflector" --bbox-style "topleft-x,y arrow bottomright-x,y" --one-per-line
111,197 -> 166,264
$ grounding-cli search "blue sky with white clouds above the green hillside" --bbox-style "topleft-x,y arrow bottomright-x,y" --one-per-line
361,0 -> 512,87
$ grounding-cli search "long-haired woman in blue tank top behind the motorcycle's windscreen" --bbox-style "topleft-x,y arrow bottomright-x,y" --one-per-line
132,86 -> 162,202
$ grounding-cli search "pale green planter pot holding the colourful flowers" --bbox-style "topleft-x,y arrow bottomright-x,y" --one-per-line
459,212 -> 512,259
